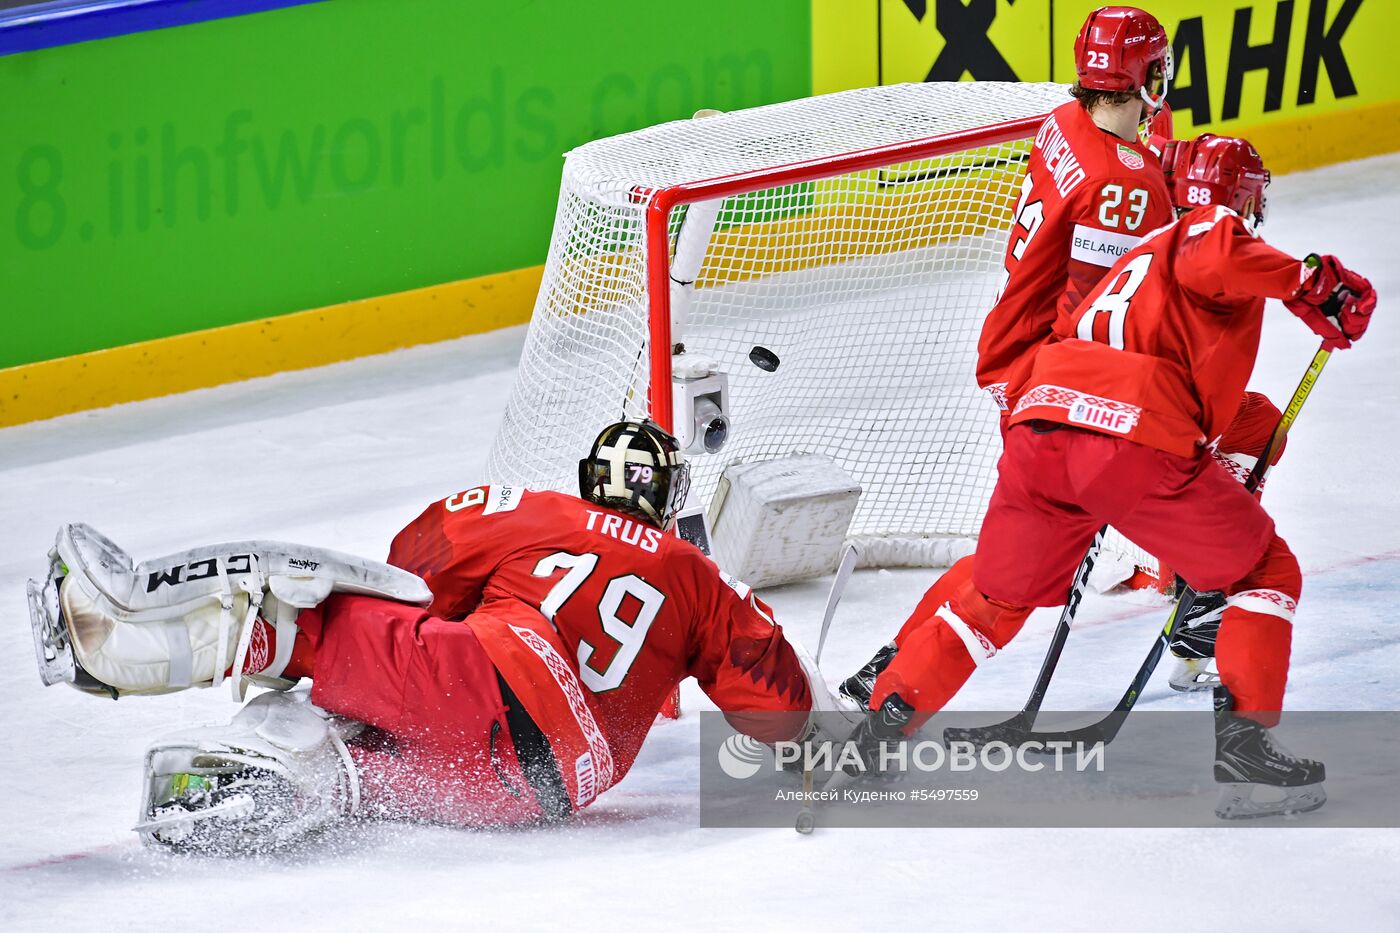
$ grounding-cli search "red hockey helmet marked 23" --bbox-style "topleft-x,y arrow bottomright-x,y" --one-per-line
1074,7 -> 1175,112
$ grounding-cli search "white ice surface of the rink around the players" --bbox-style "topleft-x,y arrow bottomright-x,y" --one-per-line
0,154 -> 1400,933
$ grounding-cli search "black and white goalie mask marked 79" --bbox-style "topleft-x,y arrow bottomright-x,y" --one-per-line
578,420 -> 690,530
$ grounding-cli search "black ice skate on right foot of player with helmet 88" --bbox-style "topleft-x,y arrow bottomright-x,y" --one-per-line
1215,686 -> 1327,820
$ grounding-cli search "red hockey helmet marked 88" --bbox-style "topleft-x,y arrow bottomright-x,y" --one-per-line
1162,133 -> 1270,228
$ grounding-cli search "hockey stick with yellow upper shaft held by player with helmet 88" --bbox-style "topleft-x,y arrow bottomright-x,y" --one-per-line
944,347 -> 1331,745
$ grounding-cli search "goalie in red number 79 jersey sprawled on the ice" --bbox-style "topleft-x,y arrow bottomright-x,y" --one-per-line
31,422 -> 812,849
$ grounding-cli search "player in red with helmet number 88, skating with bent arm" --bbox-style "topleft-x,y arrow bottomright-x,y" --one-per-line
861,136 -> 1376,813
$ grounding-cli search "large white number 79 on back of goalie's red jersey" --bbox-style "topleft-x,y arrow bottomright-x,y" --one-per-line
533,551 -> 666,693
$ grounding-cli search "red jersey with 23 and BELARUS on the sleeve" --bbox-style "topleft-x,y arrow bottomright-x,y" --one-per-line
977,101 -> 1172,405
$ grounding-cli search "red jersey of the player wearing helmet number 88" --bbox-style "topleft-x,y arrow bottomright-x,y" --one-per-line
1011,207 -> 1309,457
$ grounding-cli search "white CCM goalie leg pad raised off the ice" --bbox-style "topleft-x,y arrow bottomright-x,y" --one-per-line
28,524 -> 433,699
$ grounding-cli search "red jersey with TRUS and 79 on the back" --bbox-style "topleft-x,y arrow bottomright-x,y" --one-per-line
389,486 -> 812,792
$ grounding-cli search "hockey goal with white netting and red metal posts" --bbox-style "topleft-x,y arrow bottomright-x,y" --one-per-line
489,83 -> 1164,585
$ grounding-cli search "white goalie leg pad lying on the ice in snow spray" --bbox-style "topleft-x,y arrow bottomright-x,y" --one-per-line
136,691 -> 363,855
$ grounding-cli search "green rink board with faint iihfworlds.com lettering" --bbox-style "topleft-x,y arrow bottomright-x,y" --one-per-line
0,0 -> 812,367
